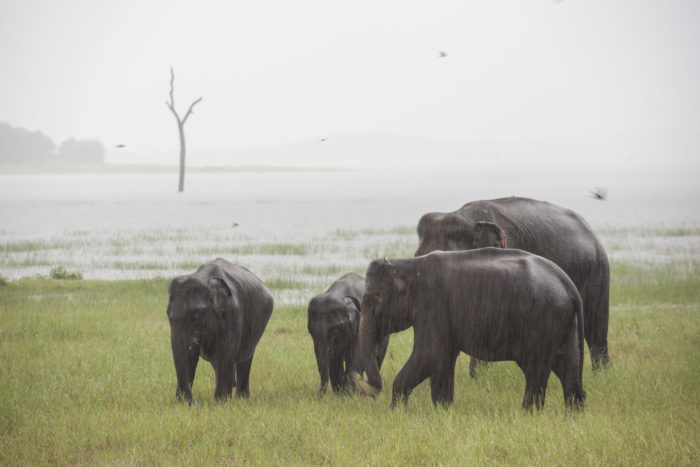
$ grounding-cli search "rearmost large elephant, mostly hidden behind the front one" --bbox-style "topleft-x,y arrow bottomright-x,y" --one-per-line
416,197 -> 610,368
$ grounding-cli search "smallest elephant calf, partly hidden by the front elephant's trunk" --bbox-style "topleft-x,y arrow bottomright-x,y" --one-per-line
307,272 -> 389,396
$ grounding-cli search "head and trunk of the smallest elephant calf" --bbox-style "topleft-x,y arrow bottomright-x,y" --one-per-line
308,294 -> 360,395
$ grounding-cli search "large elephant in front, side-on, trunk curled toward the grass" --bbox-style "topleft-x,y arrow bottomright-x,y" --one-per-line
360,248 -> 585,409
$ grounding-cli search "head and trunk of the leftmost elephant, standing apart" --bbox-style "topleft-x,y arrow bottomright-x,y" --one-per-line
167,275 -> 241,405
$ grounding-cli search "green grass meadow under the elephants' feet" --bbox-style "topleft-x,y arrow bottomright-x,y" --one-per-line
0,229 -> 700,465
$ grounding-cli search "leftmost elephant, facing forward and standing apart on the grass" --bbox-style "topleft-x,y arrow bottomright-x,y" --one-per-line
167,258 -> 273,405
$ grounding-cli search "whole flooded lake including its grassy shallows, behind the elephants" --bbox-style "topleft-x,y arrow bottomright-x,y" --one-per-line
0,163 -> 700,288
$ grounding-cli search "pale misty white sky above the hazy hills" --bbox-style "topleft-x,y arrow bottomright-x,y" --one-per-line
0,0 -> 700,162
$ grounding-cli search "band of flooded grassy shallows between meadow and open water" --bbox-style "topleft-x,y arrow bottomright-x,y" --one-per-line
0,226 -> 700,280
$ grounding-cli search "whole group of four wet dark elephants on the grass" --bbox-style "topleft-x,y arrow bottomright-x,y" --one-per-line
167,197 -> 610,409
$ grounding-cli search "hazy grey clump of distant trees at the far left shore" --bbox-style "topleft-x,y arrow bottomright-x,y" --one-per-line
0,122 -> 105,164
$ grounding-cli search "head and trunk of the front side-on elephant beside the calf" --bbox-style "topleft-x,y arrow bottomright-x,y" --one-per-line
358,258 -> 415,395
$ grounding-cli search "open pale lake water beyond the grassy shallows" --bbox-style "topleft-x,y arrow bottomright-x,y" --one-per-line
0,167 -> 700,277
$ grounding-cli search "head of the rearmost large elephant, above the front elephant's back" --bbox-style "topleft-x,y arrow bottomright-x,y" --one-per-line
415,212 -> 507,256
